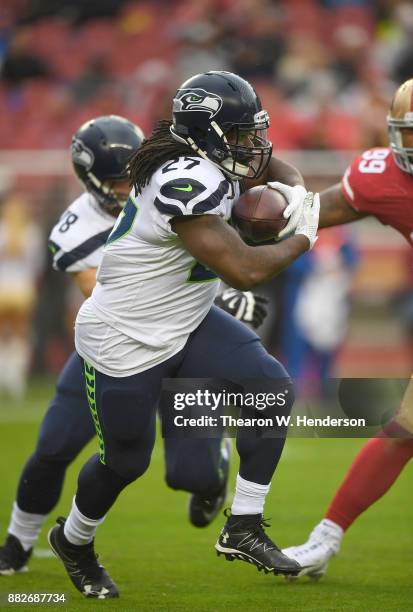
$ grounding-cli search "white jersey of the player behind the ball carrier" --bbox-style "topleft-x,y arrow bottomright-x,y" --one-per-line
49,192 -> 116,272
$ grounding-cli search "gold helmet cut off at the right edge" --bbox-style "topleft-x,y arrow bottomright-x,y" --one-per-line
387,79 -> 413,174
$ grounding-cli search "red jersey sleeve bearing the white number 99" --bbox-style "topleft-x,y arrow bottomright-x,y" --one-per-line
341,149 -> 390,214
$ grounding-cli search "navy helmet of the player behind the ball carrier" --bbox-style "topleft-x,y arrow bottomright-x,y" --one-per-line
72,115 -> 144,212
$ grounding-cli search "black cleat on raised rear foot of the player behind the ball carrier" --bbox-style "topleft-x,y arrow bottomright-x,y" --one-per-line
188,438 -> 231,527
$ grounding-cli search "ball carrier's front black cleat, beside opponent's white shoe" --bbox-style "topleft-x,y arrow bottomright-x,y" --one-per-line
215,513 -> 302,576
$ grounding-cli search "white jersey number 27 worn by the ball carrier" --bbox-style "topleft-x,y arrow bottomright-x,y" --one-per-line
75,157 -> 239,377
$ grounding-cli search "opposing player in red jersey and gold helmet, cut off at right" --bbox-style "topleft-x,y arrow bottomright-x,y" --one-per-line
284,79 -> 413,579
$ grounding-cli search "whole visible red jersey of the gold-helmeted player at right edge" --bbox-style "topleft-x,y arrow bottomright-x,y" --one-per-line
341,147 -> 413,244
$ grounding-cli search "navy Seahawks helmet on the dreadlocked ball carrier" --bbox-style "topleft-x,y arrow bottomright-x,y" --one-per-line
171,71 -> 272,178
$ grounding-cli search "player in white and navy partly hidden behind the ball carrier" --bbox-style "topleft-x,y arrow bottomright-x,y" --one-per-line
0,115 -> 265,575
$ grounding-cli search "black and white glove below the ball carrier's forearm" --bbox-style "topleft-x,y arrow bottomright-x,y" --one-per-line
215,289 -> 268,329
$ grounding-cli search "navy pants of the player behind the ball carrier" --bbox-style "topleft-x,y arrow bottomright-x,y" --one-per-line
16,353 -> 222,514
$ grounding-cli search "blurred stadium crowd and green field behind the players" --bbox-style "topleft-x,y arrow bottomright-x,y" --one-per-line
0,0 -> 413,612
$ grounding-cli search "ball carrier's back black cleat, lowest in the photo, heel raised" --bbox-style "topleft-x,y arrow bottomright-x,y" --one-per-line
48,517 -> 119,599
